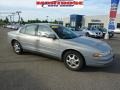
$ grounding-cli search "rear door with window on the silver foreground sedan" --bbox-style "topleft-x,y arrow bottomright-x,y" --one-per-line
18,25 -> 38,51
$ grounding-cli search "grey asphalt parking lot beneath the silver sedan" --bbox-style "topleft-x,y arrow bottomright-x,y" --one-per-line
0,27 -> 120,90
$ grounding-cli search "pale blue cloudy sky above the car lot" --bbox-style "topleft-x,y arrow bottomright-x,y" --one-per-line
0,0 -> 120,20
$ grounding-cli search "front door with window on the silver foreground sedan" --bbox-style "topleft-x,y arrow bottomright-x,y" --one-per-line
38,25 -> 59,56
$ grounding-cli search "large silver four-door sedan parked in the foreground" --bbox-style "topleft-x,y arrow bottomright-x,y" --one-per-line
8,24 -> 113,71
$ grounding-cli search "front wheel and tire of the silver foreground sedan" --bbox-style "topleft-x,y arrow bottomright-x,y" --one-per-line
63,51 -> 85,71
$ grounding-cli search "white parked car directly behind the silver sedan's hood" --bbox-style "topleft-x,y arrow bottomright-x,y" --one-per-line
81,27 -> 103,38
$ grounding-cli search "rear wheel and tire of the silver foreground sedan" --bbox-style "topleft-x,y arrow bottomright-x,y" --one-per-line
12,41 -> 23,55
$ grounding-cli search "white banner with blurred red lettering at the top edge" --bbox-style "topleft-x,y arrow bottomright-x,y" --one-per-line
36,0 -> 84,8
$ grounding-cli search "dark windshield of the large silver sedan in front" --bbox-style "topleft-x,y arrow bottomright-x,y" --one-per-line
50,25 -> 78,39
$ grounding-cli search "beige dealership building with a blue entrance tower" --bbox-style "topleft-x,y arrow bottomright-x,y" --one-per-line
63,14 -> 120,28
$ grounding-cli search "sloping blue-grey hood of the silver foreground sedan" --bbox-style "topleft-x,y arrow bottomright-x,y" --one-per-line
70,36 -> 111,52
